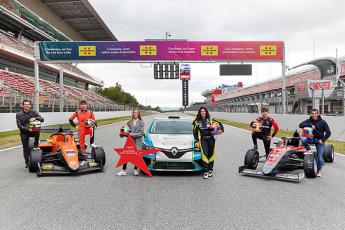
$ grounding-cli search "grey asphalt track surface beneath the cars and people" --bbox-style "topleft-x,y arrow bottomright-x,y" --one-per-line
0,115 -> 345,230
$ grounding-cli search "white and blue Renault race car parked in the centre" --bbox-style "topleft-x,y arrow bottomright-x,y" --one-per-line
143,116 -> 202,171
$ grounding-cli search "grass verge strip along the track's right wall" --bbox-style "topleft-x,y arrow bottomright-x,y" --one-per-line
218,119 -> 345,154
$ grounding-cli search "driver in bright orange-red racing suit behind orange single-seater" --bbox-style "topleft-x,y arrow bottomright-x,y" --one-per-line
69,100 -> 97,153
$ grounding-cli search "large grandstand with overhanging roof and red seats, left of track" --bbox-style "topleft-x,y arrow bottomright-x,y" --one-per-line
0,0 -> 124,112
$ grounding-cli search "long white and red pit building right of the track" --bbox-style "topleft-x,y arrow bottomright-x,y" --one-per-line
189,57 -> 345,115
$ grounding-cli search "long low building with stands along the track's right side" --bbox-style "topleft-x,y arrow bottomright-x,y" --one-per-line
188,57 -> 345,115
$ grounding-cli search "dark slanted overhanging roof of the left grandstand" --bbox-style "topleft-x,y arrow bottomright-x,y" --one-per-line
41,0 -> 117,41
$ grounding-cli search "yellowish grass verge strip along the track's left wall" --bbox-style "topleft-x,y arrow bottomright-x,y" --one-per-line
0,112 -> 152,149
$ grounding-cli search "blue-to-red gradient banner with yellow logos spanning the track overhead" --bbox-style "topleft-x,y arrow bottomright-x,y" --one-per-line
36,41 -> 284,62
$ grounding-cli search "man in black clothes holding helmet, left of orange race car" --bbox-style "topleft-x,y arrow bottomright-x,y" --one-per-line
16,100 -> 44,168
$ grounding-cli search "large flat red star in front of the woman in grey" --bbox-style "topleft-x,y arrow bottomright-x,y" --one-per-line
114,136 -> 158,176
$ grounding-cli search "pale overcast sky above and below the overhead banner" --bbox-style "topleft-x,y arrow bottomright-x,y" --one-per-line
78,0 -> 345,107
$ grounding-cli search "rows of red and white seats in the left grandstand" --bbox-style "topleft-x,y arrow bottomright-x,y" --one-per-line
0,30 -> 120,110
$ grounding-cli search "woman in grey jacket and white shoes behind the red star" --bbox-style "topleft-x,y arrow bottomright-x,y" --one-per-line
117,109 -> 145,176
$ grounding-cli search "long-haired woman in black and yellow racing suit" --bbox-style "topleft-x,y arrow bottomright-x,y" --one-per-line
193,107 -> 224,179
